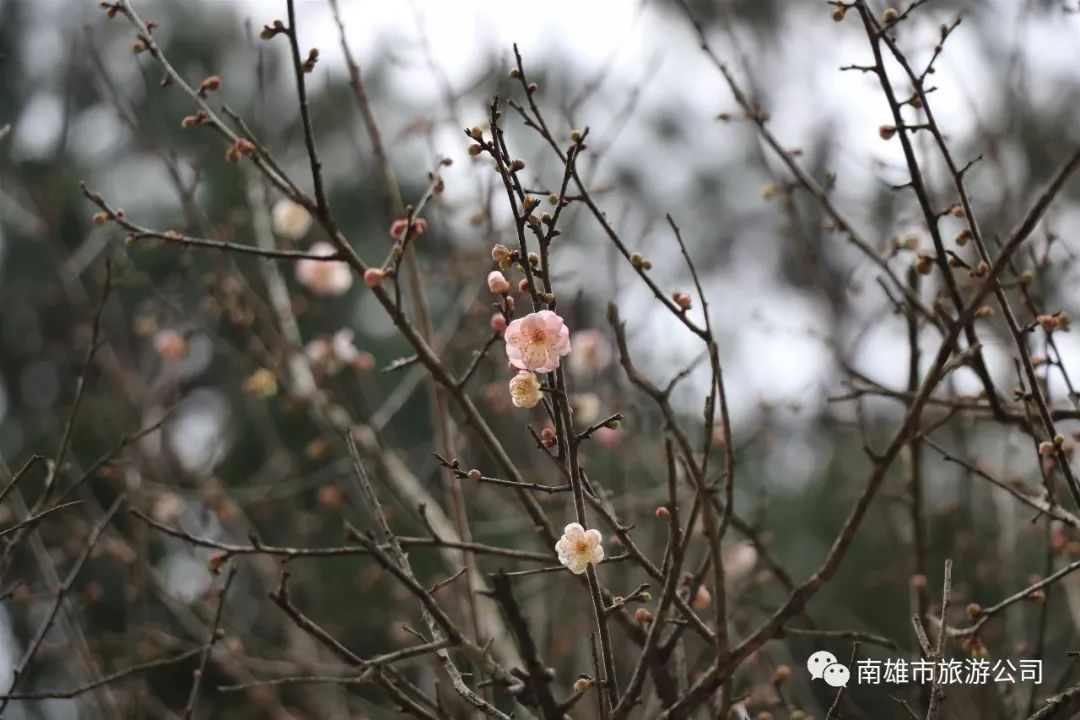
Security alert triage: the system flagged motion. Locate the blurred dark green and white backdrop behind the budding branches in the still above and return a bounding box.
[0,0,1080,718]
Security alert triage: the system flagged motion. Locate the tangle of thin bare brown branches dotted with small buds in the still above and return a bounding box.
[6,0,1080,720]
